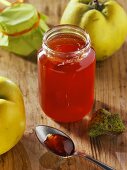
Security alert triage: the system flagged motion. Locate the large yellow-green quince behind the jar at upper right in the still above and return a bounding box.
[60,0,127,61]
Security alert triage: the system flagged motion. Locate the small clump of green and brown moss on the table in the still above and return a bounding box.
[89,109,125,137]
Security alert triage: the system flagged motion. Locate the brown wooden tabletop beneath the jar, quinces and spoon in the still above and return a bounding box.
[0,0,127,170]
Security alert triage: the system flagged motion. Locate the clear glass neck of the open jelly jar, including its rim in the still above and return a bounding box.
[39,25,91,62]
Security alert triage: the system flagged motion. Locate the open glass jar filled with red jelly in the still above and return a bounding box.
[38,25,95,122]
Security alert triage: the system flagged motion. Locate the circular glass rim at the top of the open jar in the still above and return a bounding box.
[42,24,91,55]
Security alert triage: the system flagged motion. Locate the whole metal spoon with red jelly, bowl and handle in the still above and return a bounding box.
[35,125,115,170]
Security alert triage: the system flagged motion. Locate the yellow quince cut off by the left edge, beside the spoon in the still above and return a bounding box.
[0,77,26,155]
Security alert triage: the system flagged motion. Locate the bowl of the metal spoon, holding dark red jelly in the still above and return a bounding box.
[36,125,75,157]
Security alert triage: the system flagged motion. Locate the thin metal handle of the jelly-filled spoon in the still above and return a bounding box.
[74,152,115,170]
